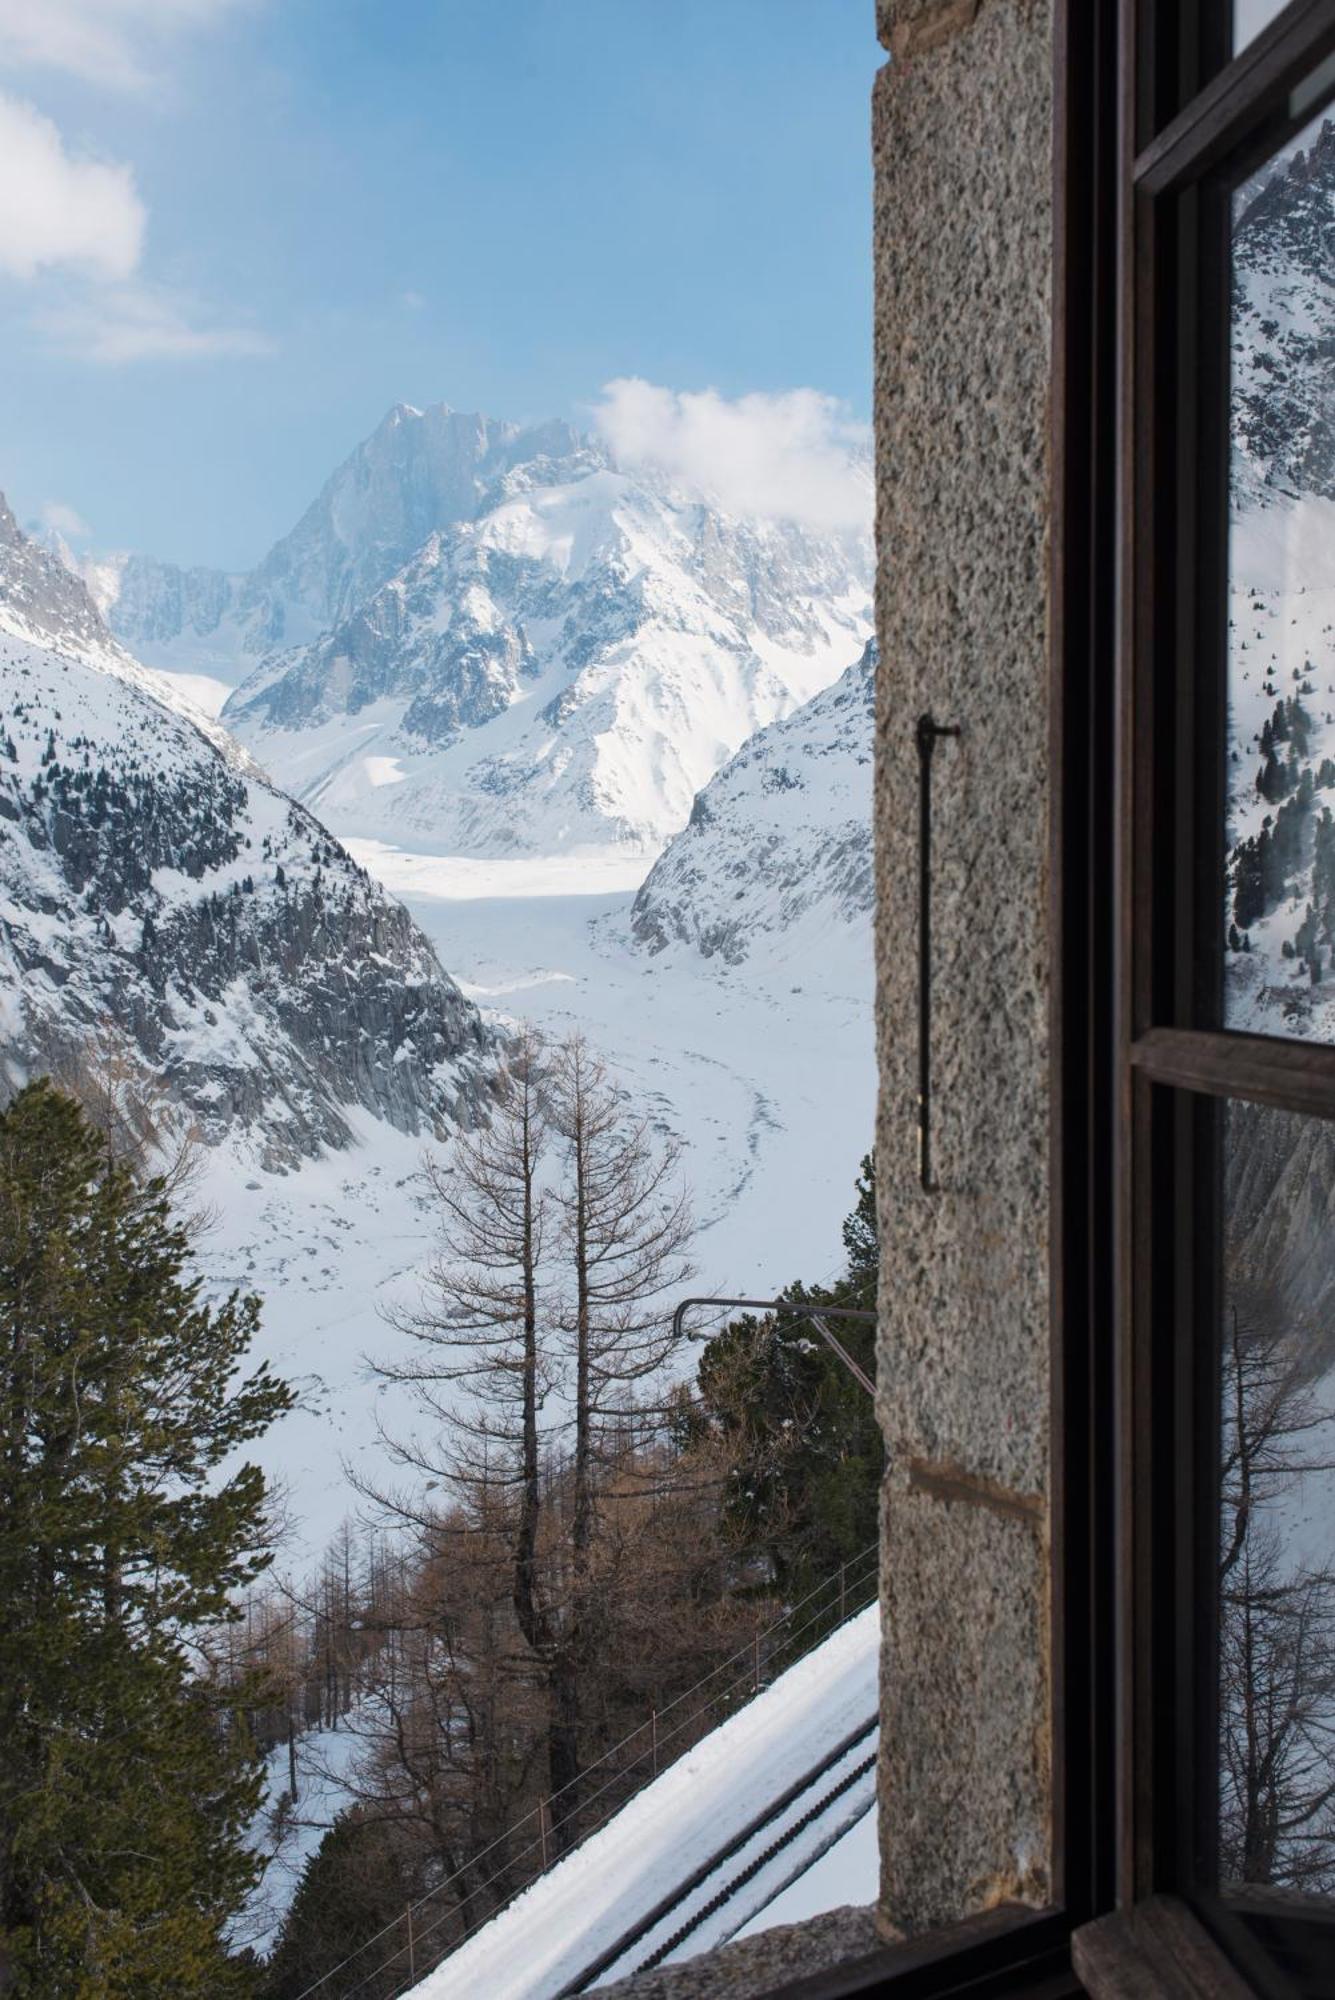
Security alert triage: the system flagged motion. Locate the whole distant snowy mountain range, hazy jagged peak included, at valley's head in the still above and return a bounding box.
[88,404,871,856]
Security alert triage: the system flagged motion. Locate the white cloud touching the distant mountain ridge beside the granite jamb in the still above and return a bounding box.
[594,376,873,530]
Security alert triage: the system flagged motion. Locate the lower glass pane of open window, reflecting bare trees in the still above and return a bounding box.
[1217,1104,1335,1968]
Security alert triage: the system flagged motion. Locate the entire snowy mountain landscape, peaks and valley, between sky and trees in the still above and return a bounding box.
[0,412,875,1984]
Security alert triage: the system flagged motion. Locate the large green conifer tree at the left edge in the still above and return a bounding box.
[0,1082,292,2000]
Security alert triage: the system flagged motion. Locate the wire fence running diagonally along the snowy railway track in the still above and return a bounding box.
[287,1544,879,2000]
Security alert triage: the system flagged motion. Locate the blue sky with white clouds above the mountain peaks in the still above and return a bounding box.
[0,0,881,566]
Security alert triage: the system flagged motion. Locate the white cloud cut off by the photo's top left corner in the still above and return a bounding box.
[0,0,238,90]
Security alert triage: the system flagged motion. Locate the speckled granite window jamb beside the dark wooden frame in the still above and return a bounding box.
[873,0,1051,1932]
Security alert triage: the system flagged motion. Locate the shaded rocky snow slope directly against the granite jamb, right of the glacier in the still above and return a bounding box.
[632,640,877,966]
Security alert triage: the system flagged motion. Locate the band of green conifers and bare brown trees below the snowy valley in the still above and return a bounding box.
[0,1036,881,2000]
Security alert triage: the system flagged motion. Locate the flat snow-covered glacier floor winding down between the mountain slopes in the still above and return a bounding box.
[195,840,875,1566]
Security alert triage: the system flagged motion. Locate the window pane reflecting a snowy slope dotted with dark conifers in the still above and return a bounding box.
[1223,105,1335,1040]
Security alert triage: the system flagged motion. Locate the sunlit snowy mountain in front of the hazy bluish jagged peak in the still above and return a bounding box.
[226,468,867,856]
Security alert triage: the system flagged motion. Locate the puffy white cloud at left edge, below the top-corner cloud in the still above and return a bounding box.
[0,94,146,278]
